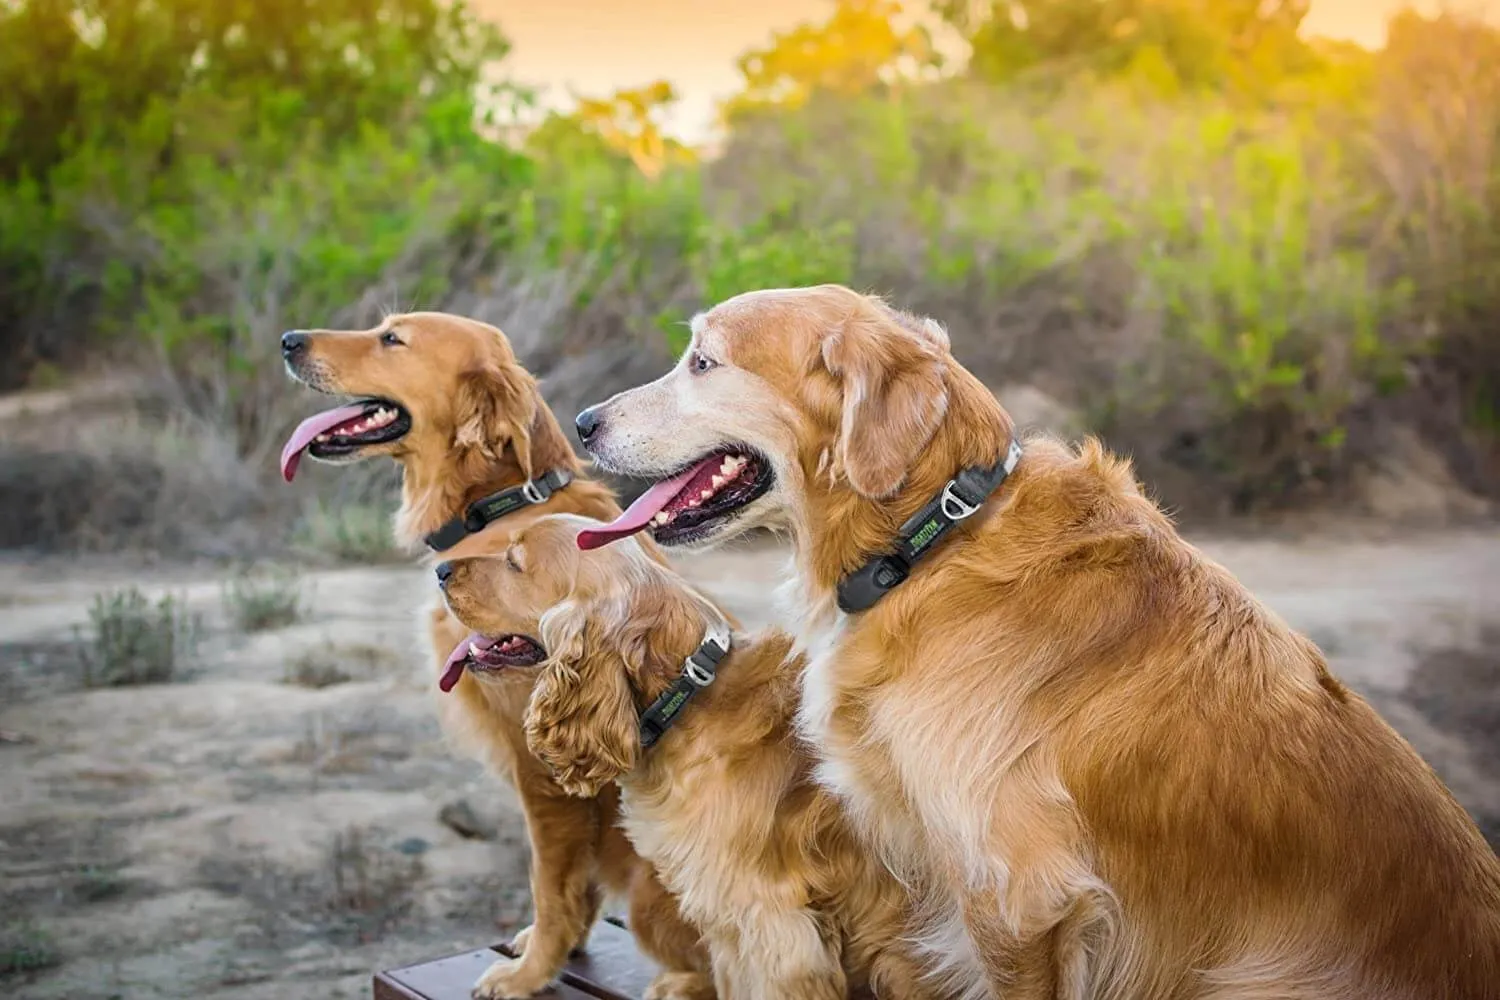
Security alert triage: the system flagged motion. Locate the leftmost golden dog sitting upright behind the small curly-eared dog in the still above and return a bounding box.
[282,313,713,1000]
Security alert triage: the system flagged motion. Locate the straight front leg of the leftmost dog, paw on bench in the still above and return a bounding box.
[474,784,603,1000]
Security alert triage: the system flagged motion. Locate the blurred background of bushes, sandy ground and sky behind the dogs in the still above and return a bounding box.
[0,0,1500,1000]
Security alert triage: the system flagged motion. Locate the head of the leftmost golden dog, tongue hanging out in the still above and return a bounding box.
[282,312,539,481]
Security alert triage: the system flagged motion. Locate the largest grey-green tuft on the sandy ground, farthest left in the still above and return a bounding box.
[80,586,201,688]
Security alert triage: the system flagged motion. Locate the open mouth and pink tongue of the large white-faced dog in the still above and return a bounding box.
[578,445,776,549]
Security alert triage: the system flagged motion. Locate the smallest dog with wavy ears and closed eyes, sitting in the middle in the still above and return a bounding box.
[438,514,936,1000]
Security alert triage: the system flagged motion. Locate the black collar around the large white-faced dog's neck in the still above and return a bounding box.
[839,439,1022,613]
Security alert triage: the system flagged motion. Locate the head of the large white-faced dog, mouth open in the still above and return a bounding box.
[578,285,1010,546]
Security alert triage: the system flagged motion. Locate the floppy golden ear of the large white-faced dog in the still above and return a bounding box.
[824,298,948,499]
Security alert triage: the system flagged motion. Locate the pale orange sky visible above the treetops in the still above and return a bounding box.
[474,0,1464,141]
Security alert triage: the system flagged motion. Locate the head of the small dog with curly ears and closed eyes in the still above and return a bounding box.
[438,514,717,796]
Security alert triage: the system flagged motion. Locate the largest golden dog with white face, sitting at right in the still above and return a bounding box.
[578,286,1500,1000]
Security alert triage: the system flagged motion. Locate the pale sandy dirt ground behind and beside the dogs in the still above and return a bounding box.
[0,531,1500,1000]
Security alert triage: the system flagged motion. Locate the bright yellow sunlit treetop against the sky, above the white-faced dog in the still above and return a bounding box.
[726,0,938,117]
